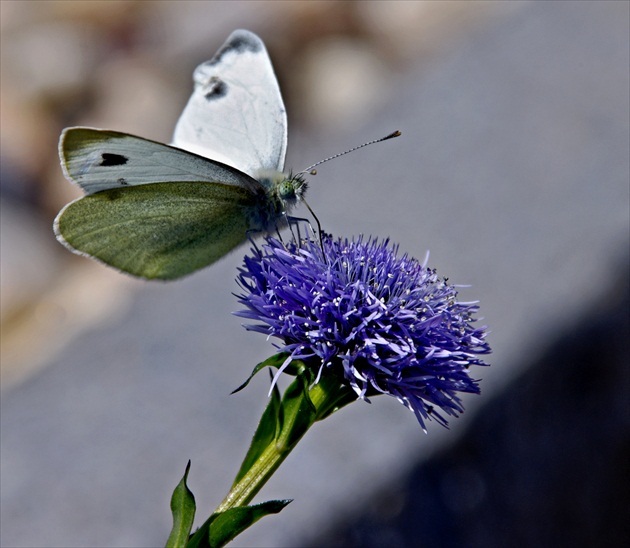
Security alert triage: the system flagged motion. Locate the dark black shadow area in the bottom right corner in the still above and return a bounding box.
[309,258,630,547]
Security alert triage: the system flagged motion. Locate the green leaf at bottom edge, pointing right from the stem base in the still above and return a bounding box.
[187,500,291,548]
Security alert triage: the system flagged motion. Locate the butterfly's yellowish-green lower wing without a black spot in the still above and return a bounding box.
[55,182,260,280]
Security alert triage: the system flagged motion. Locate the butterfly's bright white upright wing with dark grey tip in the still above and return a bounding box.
[173,30,287,177]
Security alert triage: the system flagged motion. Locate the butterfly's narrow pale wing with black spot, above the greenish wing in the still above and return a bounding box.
[59,127,262,194]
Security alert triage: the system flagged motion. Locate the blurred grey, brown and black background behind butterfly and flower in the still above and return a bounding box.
[0,0,630,547]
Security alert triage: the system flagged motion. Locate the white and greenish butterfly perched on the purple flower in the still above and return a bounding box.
[54,30,307,280]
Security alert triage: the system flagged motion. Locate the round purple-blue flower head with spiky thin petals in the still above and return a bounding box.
[236,235,490,429]
